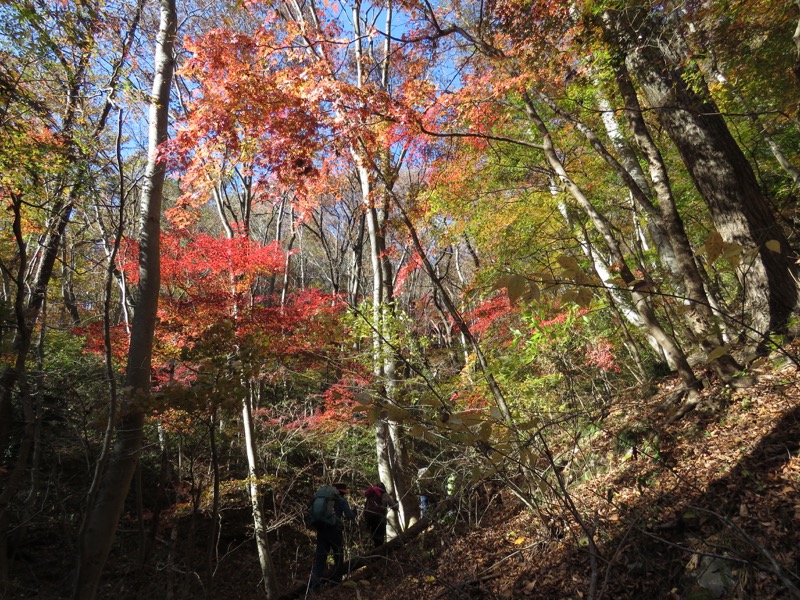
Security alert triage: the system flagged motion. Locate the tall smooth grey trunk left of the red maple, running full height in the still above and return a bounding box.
[73,0,177,600]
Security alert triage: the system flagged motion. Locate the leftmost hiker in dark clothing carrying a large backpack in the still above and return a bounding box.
[309,483,356,592]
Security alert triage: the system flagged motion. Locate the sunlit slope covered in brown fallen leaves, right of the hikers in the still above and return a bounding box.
[315,346,800,600]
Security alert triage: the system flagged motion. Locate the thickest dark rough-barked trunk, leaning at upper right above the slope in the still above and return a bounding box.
[602,10,798,342]
